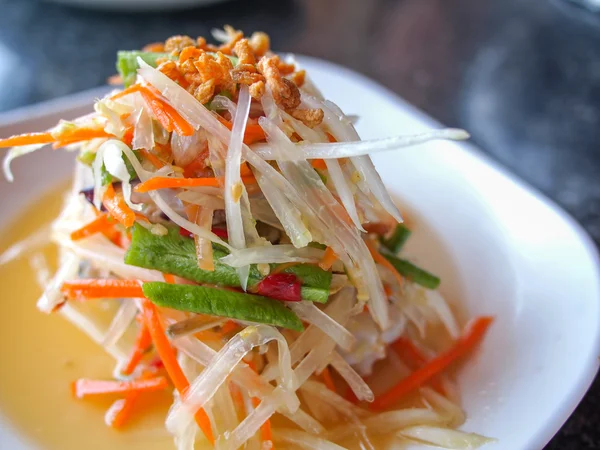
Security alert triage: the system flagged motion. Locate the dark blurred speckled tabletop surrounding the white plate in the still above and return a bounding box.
[0,0,600,450]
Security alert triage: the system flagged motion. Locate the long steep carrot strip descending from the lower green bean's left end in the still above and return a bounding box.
[142,299,215,444]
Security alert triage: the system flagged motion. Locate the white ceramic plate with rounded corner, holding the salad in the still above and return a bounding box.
[0,58,600,450]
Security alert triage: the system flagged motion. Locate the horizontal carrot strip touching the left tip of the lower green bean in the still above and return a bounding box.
[60,279,144,299]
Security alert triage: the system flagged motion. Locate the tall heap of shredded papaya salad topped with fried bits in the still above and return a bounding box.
[0,26,493,450]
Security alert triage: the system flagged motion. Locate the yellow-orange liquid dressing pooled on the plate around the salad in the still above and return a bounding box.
[0,188,465,450]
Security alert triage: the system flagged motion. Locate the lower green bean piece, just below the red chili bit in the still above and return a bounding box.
[143,282,304,331]
